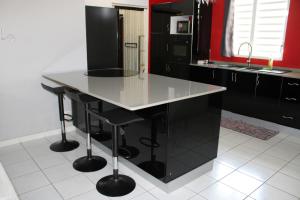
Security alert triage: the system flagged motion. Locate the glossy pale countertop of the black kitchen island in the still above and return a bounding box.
[43,71,226,111]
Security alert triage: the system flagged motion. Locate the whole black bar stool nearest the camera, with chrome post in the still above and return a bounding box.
[88,108,144,197]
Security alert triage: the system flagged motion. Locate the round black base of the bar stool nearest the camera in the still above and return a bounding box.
[97,175,136,197]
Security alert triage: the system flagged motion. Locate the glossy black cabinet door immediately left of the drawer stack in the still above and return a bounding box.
[255,74,282,122]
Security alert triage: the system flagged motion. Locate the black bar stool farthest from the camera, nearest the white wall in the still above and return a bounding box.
[41,83,79,152]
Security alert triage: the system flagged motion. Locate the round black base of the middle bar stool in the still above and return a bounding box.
[73,156,107,172]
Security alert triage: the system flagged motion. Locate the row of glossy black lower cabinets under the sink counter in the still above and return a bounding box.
[152,63,300,129]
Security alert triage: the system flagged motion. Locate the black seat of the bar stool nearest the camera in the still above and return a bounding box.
[89,108,144,126]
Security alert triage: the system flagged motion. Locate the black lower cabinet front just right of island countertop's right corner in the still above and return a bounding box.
[223,70,257,115]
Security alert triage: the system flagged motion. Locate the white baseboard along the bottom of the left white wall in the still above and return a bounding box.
[0,126,76,147]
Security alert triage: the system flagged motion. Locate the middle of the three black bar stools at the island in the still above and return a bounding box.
[65,89,107,172]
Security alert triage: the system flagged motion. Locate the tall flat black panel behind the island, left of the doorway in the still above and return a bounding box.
[85,6,122,71]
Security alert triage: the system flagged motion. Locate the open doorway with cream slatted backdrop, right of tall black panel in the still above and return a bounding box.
[116,6,146,72]
